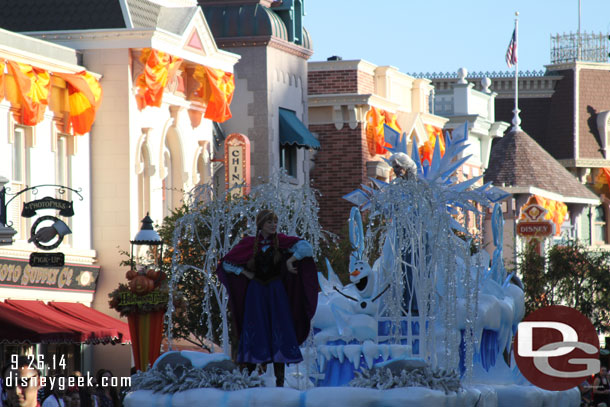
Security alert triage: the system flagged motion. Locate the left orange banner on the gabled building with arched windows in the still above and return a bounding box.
[136,48,182,110]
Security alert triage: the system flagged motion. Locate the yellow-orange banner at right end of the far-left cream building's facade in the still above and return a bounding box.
[55,71,102,134]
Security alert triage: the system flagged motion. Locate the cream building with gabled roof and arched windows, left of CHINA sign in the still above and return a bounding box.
[2,0,239,376]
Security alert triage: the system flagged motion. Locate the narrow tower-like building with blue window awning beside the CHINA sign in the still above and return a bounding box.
[199,0,320,186]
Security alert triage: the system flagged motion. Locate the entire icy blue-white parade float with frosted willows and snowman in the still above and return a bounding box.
[125,125,580,407]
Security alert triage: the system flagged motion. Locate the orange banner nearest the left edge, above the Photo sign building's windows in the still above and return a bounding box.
[7,61,51,126]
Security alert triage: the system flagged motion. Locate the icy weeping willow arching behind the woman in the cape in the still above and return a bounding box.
[158,176,328,354]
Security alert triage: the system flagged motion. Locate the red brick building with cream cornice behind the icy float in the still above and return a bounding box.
[308,60,447,233]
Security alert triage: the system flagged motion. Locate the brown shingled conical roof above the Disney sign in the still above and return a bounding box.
[485,131,599,202]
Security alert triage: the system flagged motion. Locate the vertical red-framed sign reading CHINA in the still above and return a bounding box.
[224,133,250,197]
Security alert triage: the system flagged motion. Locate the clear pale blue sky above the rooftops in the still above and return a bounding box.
[304,0,610,73]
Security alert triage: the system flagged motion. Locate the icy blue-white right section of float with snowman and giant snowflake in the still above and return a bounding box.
[313,124,523,385]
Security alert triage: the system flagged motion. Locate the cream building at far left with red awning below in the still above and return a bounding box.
[0,30,129,373]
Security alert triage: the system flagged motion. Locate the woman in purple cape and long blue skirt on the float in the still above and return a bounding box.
[216,210,318,387]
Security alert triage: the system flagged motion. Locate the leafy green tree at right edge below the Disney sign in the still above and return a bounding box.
[519,241,610,332]
